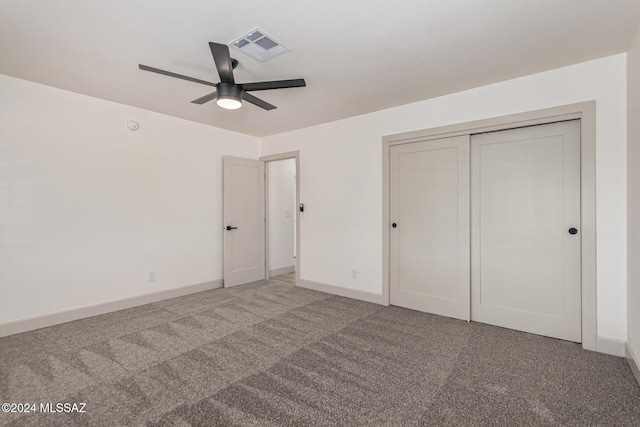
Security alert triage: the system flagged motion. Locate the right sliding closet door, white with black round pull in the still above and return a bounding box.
[471,121,581,342]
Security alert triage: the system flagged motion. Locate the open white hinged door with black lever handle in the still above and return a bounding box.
[223,157,266,287]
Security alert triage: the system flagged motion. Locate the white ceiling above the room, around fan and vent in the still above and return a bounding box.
[0,0,640,136]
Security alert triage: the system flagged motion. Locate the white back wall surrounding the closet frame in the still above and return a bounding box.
[261,54,627,340]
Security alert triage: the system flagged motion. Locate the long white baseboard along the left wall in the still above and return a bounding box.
[0,279,222,337]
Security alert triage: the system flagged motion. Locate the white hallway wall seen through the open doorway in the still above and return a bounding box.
[269,159,296,270]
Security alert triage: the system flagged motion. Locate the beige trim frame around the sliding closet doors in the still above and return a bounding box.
[382,101,597,351]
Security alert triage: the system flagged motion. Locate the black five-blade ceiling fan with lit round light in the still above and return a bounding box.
[138,42,307,110]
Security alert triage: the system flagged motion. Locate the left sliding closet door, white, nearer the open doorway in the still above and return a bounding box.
[389,135,470,320]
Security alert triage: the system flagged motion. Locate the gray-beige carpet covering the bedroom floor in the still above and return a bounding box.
[0,280,640,426]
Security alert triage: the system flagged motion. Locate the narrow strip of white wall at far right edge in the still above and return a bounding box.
[627,26,640,361]
